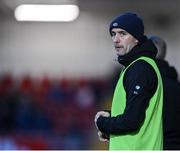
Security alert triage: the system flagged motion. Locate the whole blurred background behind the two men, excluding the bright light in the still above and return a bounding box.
[0,0,180,150]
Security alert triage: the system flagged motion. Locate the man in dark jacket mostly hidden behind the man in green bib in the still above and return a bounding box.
[149,36,180,150]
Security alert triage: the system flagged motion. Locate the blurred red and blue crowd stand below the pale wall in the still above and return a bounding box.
[0,74,116,149]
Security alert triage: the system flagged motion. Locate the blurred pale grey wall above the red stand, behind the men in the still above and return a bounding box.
[0,0,180,77]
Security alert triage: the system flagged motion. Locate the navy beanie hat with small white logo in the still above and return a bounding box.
[109,12,144,41]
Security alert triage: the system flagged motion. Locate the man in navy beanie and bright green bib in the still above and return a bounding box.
[94,12,163,150]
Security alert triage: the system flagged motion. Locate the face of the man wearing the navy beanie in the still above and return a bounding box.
[111,28,138,56]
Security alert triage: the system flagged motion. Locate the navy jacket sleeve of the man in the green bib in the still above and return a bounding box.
[97,61,158,135]
